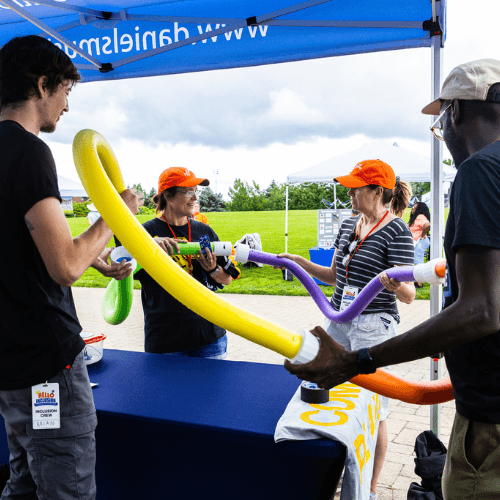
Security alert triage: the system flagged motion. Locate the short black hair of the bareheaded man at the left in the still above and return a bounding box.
[0,35,81,110]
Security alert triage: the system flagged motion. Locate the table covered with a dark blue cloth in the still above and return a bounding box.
[0,350,345,500]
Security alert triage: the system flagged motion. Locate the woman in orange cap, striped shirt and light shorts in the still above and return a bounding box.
[281,160,415,500]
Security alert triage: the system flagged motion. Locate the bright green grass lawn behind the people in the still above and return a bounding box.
[68,209,448,299]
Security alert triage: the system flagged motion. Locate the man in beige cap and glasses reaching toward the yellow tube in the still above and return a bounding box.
[285,59,500,500]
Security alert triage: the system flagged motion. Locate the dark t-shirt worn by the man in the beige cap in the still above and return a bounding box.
[444,142,500,424]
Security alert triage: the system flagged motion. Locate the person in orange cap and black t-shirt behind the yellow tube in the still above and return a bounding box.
[127,167,240,359]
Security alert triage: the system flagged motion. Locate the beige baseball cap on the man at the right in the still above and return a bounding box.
[422,59,500,115]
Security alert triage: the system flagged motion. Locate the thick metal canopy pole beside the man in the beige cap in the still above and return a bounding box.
[430,5,444,437]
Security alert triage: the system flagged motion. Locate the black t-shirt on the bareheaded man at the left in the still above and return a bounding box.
[0,121,85,390]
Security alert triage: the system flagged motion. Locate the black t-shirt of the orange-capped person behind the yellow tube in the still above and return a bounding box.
[135,218,239,353]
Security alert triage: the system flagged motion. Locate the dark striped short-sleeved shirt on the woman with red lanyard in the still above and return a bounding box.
[332,215,414,323]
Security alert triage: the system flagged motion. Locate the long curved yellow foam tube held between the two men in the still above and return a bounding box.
[73,129,302,359]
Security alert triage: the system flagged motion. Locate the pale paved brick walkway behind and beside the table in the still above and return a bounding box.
[73,288,455,500]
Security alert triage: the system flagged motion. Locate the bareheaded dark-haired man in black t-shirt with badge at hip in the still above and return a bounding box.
[0,36,141,500]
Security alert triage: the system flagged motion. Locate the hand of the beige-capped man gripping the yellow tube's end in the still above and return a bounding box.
[285,326,358,389]
